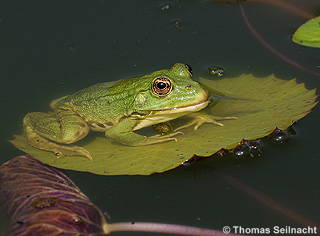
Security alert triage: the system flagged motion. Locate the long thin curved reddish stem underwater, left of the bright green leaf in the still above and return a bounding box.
[239,3,320,77]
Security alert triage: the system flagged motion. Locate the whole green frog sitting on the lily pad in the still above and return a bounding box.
[23,63,229,159]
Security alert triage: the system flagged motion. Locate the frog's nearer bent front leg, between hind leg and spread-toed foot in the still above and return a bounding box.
[105,118,182,146]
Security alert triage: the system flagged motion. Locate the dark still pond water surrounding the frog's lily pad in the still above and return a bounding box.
[0,0,320,235]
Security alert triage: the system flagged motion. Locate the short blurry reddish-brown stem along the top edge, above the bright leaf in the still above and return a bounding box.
[247,0,315,19]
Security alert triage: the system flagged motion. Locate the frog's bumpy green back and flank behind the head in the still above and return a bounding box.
[54,78,144,123]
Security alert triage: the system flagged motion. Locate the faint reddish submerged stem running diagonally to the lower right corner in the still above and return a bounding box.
[218,173,320,229]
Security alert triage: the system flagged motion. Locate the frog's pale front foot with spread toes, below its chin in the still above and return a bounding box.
[174,112,238,131]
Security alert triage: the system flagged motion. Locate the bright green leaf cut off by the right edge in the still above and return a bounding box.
[292,16,320,48]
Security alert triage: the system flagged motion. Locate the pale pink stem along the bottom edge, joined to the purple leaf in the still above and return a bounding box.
[108,222,241,236]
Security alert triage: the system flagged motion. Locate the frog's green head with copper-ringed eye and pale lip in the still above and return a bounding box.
[134,63,208,116]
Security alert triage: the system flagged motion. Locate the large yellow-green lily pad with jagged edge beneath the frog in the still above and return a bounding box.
[11,74,317,175]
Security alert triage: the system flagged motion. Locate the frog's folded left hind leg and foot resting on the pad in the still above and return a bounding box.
[23,110,92,159]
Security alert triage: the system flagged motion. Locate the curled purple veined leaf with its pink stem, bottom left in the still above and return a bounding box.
[0,155,238,236]
